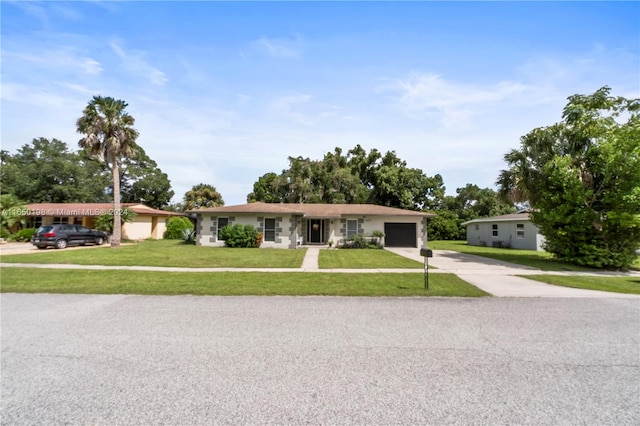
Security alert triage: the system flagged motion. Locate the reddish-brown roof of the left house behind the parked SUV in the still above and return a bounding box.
[26,203,182,217]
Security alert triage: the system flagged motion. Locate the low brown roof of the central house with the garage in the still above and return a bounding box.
[187,202,435,218]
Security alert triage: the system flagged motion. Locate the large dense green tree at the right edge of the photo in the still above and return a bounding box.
[498,87,640,269]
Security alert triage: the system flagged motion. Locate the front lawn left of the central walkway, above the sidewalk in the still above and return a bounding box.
[0,240,306,268]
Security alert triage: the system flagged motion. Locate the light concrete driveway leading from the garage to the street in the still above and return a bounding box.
[387,248,640,300]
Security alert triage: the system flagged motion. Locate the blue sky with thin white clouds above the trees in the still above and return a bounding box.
[0,0,640,205]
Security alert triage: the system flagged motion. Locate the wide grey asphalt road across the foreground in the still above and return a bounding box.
[1,293,640,425]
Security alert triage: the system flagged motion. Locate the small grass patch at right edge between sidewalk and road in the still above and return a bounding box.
[523,275,640,294]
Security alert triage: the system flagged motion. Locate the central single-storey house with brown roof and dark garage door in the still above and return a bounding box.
[187,202,435,248]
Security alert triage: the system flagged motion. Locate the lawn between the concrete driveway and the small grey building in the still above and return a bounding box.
[429,241,593,272]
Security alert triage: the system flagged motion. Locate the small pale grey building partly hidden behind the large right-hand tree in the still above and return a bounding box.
[462,211,544,251]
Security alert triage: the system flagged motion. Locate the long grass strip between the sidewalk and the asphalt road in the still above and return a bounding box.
[0,268,488,297]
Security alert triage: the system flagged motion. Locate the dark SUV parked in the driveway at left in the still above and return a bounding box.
[31,225,107,249]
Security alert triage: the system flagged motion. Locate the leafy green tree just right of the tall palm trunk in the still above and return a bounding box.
[121,146,174,209]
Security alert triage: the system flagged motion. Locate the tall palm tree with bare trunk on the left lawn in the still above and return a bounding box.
[76,96,138,248]
